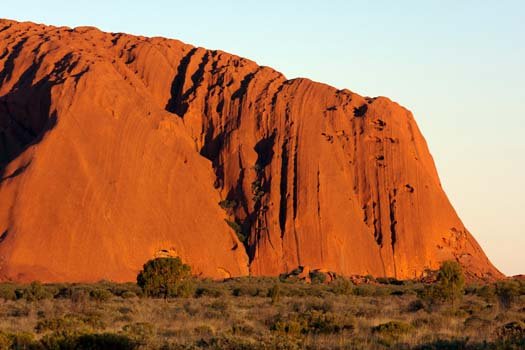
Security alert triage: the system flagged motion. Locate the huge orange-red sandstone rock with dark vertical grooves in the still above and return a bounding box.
[0,20,501,281]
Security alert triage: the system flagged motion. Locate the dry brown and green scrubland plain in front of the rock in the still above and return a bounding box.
[0,262,525,349]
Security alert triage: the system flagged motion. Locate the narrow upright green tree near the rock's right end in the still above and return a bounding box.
[433,260,465,304]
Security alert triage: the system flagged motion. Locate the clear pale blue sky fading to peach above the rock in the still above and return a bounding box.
[0,0,525,275]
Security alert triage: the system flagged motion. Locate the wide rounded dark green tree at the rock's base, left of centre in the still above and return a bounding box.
[137,257,193,298]
